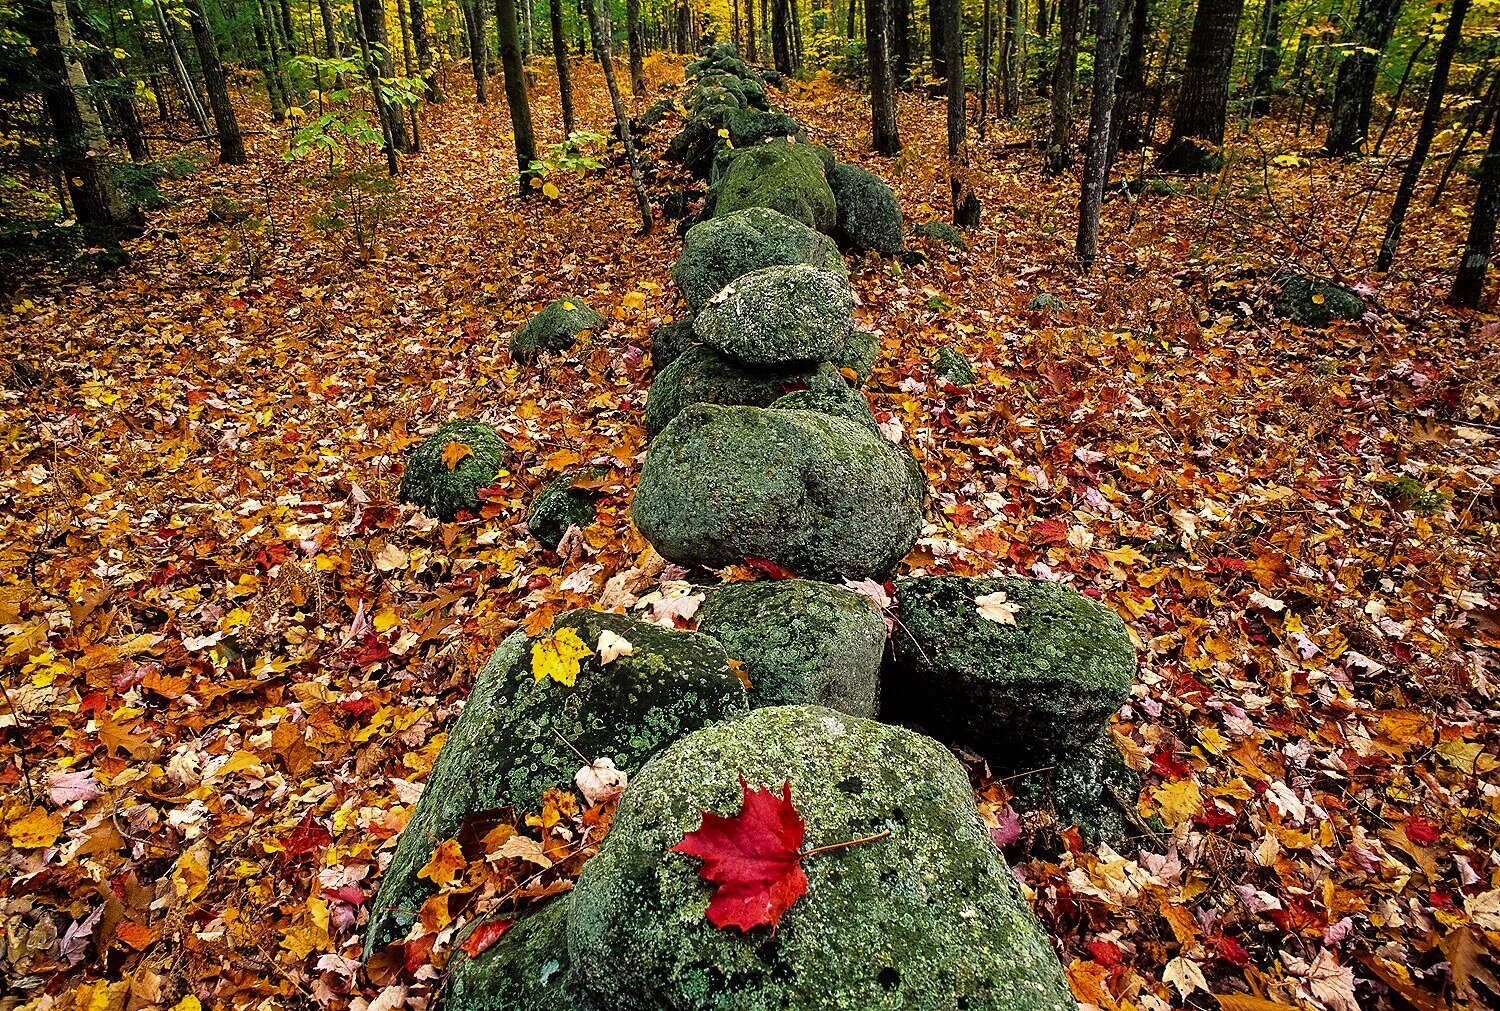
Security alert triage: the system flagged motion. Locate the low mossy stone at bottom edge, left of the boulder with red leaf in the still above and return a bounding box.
[443,896,588,1011]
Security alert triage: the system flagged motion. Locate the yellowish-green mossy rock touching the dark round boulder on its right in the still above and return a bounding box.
[711,141,837,233]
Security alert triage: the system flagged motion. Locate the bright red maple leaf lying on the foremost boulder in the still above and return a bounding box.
[672,776,807,930]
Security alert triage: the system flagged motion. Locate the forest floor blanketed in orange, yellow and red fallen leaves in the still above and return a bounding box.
[0,53,1500,1011]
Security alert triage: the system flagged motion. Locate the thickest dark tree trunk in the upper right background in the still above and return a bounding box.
[1157,0,1245,173]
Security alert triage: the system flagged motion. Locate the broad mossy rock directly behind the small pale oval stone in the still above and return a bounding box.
[672,207,849,312]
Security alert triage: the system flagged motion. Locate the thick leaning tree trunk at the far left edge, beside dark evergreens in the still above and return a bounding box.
[17,0,143,246]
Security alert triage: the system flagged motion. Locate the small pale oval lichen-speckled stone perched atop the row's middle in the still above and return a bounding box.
[693,264,854,365]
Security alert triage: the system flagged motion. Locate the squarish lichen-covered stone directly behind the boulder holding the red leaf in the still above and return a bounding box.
[698,579,885,717]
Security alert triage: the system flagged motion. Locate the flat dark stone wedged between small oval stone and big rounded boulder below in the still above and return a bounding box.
[644,345,849,435]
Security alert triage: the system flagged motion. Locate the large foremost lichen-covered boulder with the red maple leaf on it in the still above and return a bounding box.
[569,707,1076,1011]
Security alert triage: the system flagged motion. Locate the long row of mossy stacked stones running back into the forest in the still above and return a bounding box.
[384,45,1136,1011]
